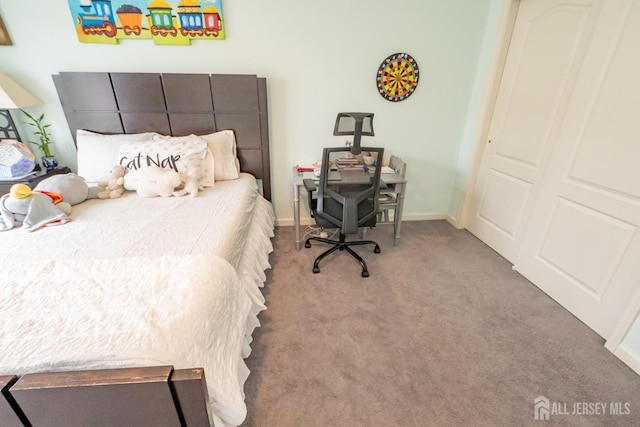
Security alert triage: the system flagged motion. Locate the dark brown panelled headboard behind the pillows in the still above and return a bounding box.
[53,72,271,200]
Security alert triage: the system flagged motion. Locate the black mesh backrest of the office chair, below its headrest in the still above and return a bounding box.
[315,147,384,234]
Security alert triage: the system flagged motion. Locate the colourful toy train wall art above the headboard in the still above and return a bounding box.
[68,0,225,45]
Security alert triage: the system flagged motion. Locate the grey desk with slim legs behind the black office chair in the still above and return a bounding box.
[292,167,407,249]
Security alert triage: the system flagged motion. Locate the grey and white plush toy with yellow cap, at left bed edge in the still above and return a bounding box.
[0,184,71,231]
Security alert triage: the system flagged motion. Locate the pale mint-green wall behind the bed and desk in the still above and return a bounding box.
[0,0,492,224]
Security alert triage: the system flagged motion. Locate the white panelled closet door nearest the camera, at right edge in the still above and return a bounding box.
[515,0,640,339]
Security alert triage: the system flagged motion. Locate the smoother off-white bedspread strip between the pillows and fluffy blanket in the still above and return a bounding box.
[0,174,258,267]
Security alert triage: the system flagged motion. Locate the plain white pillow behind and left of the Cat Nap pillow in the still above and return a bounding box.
[76,129,156,183]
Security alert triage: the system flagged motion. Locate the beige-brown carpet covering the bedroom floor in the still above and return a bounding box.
[243,221,640,427]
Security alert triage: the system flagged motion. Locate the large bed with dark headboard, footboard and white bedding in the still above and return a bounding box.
[0,73,274,426]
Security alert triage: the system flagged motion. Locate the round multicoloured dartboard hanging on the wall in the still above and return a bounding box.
[377,53,420,102]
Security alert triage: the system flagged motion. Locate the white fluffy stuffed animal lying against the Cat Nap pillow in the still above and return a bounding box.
[124,166,182,197]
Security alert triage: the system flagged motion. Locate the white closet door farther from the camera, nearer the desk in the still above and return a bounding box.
[467,0,602,262]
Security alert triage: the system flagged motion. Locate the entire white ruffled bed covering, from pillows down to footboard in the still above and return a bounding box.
[0,175,273,425]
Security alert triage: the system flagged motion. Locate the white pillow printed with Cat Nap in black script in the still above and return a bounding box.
[118,134,215,187]
